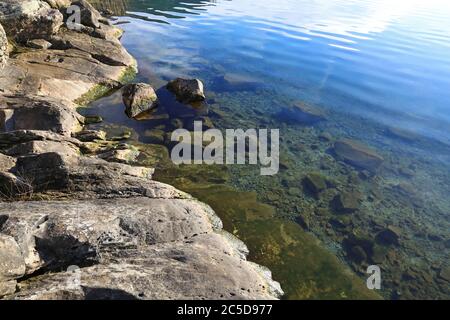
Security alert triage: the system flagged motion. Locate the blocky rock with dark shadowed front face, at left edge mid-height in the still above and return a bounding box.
[0,96,83,135]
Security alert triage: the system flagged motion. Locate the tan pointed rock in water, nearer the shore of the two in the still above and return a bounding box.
[122,83,158,118]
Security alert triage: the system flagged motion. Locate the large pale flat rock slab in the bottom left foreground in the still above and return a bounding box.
[0,197,282,299]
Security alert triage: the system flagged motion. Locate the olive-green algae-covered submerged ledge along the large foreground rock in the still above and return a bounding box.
[154,165,380,299]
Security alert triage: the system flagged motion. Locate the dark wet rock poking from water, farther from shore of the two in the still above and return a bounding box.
[166,78,206,104]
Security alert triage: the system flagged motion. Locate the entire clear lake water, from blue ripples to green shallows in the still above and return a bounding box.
[83,0,450,299]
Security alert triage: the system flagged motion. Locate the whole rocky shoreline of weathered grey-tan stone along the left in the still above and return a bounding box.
[0,0,282,299]
